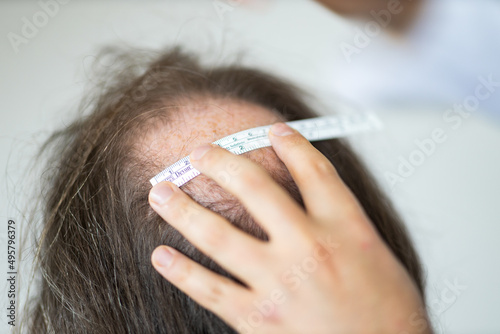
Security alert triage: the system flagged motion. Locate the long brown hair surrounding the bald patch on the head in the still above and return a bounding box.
[25,48,424,334]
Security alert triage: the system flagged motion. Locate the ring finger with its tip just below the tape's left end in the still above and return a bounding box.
[149,182,266,282]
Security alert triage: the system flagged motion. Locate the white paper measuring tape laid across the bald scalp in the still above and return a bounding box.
[149,112,382,187]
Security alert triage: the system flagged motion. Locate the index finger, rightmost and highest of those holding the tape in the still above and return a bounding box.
[269,123,360,220]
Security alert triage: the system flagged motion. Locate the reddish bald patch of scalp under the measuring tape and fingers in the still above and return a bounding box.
[141,98,302,239]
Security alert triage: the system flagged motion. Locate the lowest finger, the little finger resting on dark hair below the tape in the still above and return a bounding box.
[151,246,251,324]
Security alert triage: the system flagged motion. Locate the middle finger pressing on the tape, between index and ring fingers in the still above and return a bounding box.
[189,145,306,239]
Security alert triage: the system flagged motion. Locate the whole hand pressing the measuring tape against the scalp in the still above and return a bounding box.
[149,123,430,334]
